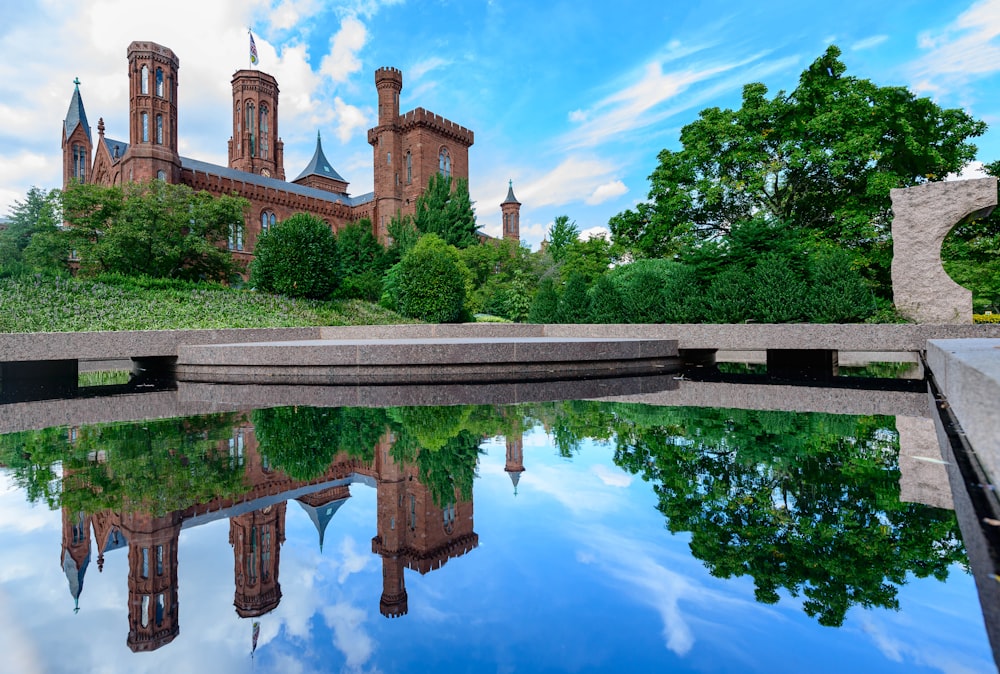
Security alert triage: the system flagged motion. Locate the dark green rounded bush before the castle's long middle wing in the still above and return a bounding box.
[250,213,340,299]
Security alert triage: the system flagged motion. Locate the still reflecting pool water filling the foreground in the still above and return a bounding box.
[0,401,996,674]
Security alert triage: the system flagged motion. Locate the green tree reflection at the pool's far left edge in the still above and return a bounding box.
[0,414,244,515]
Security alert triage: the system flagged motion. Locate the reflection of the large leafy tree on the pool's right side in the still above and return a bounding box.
[596,406,965,626]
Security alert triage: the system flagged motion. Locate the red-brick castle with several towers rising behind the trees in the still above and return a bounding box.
[61,41,520,262]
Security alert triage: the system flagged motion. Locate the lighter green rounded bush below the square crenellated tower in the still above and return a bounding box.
[385,234,468,323]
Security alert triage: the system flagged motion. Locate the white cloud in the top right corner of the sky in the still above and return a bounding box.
[913,0,1000,91]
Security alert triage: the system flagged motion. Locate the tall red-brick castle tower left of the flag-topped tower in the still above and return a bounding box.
[122,42,181,183]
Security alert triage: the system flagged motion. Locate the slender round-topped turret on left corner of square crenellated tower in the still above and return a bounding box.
[368,68,403,241]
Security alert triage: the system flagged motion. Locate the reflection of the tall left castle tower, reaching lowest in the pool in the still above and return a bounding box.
[121,512,181,653]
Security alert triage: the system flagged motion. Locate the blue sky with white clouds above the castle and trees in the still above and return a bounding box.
[0,0,1000,247]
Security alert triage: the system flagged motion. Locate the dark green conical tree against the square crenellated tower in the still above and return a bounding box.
[413,173,479,248]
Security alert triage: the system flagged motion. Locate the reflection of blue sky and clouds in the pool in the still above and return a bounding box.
[0,431,993,674]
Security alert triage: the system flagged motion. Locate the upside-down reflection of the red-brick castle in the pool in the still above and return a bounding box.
[61,424,524,652]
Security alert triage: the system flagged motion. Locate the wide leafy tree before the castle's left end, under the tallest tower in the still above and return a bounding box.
[62,180,248,280]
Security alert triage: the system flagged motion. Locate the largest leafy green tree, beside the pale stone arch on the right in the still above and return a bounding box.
[610,46,986,292]
